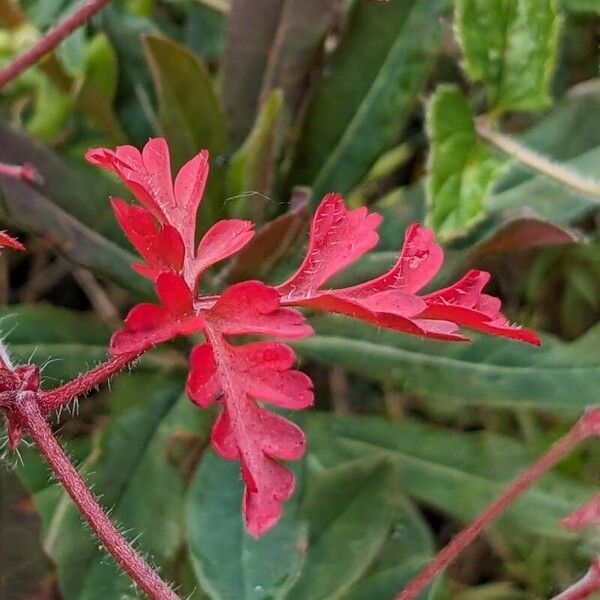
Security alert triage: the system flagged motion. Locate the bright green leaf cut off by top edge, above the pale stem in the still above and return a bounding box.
[455,0,560,112]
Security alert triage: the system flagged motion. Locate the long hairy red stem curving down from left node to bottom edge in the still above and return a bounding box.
[13,392,178,600]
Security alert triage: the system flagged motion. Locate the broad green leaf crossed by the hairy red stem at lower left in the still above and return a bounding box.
[45,376,208,600]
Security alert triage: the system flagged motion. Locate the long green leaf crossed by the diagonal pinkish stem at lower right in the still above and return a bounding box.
[307,412,591,539]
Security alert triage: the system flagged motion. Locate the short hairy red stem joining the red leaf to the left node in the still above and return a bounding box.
[38,352,141,414]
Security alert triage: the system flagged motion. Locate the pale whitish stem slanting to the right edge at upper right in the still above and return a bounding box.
[475,119,600,199]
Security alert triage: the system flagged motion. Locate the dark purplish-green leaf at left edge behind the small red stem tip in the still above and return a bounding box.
[0,125,152,295]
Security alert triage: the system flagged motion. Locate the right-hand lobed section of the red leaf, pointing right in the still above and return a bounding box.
[277,194,539,345]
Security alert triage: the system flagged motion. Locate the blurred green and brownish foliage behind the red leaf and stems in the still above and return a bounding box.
[0,0,600,600]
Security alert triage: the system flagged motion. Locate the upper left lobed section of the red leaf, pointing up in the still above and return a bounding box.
[86,138,254,289]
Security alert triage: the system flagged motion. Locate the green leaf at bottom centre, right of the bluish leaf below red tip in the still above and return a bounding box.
[288,459,392,600]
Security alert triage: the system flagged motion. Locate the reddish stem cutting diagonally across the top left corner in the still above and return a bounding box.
[0,0,110,88]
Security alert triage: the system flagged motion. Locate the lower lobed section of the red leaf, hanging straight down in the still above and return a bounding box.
[187,332,313,537]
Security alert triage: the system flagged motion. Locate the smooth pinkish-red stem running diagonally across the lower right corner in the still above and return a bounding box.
[396,409,600,600]
